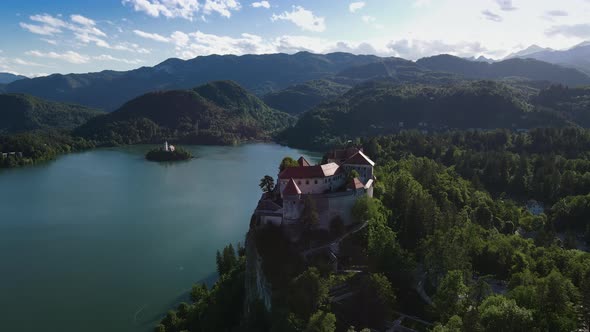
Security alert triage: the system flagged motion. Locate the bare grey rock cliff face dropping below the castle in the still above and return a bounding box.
[245,230,272,312]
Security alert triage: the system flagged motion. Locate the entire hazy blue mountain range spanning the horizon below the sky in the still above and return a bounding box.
[0,52,590,111]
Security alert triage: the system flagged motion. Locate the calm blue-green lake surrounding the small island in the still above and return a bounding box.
[0,144,320,332]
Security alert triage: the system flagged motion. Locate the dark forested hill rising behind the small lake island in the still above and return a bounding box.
[75,81,294,145]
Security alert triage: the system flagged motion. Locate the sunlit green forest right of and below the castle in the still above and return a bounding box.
[157,128,590,332]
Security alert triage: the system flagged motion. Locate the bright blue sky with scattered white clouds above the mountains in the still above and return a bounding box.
[0,0,590,77]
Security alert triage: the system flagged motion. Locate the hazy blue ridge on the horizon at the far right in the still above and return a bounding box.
[416,55,590,86]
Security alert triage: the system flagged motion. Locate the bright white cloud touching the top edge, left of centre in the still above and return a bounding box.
[123,0,241,21]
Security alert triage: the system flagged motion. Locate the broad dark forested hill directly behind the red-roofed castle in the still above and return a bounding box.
[280,81,568,148]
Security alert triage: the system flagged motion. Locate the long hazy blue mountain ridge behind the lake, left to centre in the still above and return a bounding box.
[5,52,379,111]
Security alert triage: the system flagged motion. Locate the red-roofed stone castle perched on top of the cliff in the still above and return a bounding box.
[254,148,375,229]
